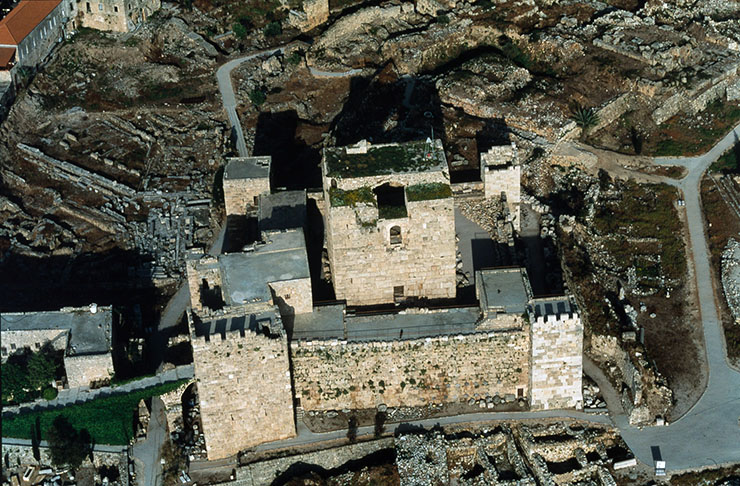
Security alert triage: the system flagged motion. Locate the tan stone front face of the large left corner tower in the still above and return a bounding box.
[192,331,295,460]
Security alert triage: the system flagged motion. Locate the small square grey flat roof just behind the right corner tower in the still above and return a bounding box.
[476,268,529,314]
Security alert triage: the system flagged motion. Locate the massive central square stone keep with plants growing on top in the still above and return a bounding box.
[322,140,456,305]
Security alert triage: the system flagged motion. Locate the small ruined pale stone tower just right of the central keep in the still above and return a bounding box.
[480,142,522,231]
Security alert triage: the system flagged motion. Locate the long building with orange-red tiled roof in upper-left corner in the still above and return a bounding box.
[0,0,69,82]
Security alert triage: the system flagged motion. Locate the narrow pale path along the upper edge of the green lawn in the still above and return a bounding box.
[3,364,194,418]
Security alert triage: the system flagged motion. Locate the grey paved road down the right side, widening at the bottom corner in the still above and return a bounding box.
[613,125,740,471]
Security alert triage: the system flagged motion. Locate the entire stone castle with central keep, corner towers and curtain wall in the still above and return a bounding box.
[181,140,582,459]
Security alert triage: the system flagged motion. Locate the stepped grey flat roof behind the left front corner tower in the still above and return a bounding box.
[218,228,311,305]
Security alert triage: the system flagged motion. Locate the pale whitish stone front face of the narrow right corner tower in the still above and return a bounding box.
[531,313,583,410]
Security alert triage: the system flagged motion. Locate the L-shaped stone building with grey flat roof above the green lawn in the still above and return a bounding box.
[0,304,114,388]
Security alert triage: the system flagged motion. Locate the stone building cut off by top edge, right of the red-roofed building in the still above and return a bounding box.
[69,0,162,32]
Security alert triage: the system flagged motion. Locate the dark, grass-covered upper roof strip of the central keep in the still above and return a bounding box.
[324,140,447,178]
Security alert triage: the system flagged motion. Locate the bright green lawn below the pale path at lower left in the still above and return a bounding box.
[3,380,187,445]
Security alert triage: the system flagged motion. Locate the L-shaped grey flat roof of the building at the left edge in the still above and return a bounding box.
[0,306,113,356]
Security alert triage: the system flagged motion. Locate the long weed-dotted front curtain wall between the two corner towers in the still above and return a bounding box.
[291,327,529,410]
